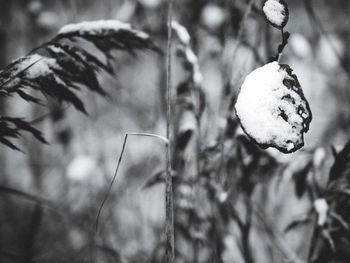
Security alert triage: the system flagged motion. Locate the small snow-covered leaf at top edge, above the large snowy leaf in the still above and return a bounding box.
[263,0,288,27]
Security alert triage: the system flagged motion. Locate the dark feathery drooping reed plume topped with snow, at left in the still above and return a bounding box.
[0,20,160,150]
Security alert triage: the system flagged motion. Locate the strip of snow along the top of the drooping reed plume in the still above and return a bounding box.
[58,20,149,39]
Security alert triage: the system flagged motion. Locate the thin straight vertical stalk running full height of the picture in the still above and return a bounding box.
[165,0,175,263]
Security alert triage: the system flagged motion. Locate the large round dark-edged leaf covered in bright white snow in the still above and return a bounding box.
[235,62,312,153]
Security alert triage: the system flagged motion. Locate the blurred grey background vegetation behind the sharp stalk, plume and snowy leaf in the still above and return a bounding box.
[0,0,350,263]
